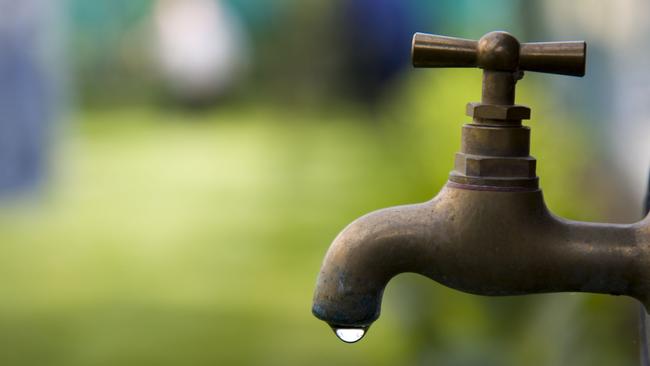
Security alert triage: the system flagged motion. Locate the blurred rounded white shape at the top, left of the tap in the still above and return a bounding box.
[154,0,247,99]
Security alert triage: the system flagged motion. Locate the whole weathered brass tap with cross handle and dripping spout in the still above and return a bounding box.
[312,32,650,340]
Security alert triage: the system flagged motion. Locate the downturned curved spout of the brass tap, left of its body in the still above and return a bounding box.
[312,194,438,328]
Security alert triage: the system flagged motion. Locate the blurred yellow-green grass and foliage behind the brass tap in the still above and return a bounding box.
[0,72,635,365]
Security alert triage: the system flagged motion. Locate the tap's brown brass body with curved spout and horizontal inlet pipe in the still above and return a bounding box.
[312,182,650,328]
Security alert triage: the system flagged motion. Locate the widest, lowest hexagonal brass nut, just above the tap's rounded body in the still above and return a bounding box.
[454,153,537,178]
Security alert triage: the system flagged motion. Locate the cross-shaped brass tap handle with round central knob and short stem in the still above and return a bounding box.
[411,31,587,105]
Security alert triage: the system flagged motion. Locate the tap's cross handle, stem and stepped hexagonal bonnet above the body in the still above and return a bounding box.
[412,32,586,190]
